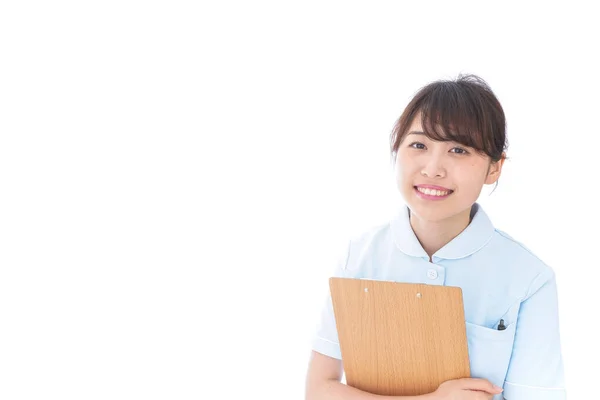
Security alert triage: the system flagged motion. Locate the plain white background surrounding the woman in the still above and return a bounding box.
[0,1,600,400]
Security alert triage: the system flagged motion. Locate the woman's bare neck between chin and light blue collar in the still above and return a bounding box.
[410,208,471,261]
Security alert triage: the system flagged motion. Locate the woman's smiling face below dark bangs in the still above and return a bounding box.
[396,115,503,222]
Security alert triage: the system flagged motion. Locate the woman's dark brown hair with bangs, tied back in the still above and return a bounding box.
[390,74,508,162]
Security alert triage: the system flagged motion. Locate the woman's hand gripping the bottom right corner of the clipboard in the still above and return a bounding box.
[432,378,502,400]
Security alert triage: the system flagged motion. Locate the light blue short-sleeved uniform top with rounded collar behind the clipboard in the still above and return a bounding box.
[313,203,566,400]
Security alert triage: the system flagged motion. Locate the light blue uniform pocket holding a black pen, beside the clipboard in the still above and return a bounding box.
[466,322,517,399]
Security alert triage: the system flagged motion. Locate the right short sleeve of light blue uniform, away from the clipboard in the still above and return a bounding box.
[503,269,566,400]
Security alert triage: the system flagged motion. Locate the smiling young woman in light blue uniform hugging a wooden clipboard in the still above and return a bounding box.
[306,75,565,400]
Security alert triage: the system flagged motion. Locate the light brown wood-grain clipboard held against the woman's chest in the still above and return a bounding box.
[329,277,470,396]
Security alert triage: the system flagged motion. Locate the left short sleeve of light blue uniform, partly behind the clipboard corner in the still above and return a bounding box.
[312,243,350,360]
